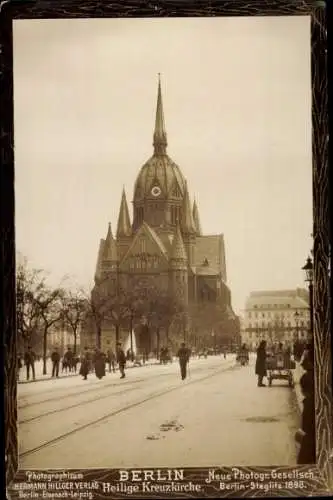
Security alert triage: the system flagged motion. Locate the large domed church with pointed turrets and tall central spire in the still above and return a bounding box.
[85,78,239,349]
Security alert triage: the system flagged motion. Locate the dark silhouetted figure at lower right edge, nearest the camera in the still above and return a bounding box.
[295,371,316,465]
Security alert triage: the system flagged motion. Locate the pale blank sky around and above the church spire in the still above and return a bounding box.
[14,16,312,313]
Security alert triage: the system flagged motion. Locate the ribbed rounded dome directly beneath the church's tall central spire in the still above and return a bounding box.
[134,154,186,200]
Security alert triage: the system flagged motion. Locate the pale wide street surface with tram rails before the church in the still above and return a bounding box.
[18,355,300,469]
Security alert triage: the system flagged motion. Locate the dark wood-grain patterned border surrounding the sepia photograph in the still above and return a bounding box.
[0,0,333,498]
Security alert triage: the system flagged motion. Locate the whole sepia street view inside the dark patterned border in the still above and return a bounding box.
[13,15,316,476]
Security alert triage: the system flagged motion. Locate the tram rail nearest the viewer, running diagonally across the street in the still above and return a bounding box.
[19,364,238,458]
